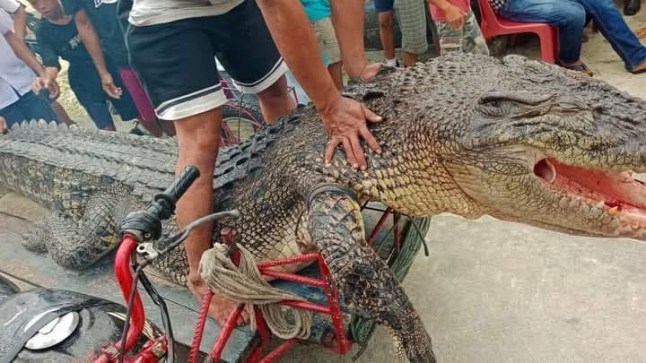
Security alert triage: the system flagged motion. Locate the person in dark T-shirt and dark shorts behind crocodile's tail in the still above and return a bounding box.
[29,0,139,131]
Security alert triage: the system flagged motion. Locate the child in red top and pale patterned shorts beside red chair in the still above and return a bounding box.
[430,0,489,55]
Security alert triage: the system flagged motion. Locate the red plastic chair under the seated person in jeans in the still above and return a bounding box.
[478,0,558,63]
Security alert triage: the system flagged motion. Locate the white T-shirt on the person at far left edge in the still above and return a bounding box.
[0,0,36,109]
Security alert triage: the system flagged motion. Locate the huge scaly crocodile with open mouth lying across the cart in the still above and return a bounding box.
[0,54,646,361]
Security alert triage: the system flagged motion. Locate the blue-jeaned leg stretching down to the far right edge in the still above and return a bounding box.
[571,0,646,71]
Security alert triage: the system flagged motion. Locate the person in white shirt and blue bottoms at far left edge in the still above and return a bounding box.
[0,0,60,127]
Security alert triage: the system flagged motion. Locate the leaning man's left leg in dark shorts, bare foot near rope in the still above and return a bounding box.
[125,15,243,324]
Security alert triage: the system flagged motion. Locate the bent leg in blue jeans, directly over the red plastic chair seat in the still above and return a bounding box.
[499,0,585,65]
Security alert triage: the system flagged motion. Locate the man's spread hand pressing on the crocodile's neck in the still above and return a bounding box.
[320,95,382,170]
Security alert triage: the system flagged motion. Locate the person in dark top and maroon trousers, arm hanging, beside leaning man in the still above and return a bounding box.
[60,0,175,137]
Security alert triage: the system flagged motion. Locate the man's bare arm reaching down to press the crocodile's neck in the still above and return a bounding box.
[258,0,381,169]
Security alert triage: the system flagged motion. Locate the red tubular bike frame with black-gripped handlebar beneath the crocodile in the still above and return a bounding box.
[88,168,428,363]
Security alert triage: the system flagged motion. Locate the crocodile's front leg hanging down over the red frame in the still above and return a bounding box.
[309,190,435,362]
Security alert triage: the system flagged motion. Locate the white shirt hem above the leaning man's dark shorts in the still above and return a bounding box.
[129,0,246,26]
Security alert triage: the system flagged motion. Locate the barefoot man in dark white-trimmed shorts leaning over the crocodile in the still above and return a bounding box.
[119,0,381,324]
